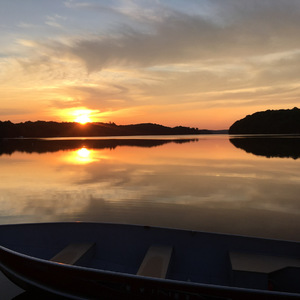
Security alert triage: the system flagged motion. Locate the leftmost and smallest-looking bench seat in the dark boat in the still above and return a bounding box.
[50,243,95,265]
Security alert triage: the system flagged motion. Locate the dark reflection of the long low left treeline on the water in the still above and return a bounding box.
[0,139,197,156]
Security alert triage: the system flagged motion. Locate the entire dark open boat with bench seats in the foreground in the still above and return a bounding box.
[0,222,300,300]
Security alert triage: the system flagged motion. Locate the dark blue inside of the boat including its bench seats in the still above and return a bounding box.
[0,223,300,293]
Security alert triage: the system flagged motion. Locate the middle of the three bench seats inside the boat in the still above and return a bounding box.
[137,246,173,278]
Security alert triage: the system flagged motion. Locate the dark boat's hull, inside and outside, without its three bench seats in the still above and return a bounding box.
[0,223,300,299]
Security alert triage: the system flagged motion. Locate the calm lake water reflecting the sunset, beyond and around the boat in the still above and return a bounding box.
[0,135,300,300]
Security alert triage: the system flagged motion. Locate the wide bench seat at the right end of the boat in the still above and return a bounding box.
[229,252,300,274]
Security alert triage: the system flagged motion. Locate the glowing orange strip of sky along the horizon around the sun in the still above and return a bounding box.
[0,105,293,130]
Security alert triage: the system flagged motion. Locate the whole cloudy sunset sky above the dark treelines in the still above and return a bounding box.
[0,0,300,129]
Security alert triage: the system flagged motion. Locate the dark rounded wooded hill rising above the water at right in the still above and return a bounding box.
[229,107,300,134]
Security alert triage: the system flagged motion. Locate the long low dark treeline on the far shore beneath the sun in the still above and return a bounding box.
[0,121,217,138]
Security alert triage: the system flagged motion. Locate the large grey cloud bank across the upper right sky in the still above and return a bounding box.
[53,0,300,72]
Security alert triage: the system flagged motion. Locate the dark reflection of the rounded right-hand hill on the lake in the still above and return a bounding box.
[230,136,300,159]
